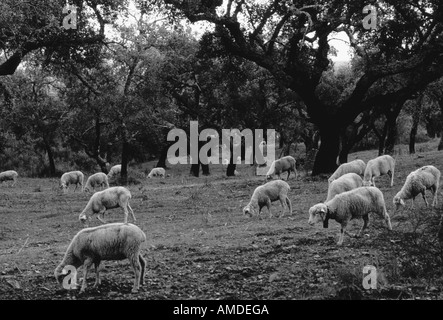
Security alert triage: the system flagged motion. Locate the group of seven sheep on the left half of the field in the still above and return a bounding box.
[0,165,165,292]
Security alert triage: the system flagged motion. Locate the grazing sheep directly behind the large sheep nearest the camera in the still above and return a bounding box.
[79,187,136,223]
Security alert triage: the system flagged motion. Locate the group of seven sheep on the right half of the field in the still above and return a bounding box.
[243,155,441,245]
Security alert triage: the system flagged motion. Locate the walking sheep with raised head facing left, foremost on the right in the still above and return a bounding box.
[308,187,392,245]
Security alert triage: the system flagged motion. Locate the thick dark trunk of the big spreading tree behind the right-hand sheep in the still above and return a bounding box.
[312,125,340,176]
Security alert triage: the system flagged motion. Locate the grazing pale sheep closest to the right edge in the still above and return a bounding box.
[393,166,441,209]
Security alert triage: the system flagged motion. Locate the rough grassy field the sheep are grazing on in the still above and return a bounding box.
[0,141,443,300]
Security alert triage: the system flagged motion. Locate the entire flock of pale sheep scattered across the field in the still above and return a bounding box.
[0,155,440,292]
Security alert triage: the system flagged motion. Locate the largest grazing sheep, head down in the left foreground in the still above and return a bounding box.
[54,223,146,293]
